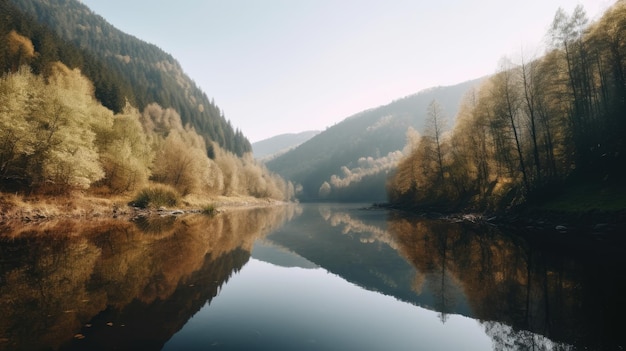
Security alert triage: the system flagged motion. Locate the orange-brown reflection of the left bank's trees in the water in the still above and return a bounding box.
[0,207,294,350]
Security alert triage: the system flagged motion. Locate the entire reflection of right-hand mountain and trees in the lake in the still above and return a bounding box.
[265,205,626,350]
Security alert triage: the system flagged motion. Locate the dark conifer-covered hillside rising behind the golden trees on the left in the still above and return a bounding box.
[7,0,251,156]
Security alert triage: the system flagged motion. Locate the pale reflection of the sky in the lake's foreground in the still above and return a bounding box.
[164,258,492,350]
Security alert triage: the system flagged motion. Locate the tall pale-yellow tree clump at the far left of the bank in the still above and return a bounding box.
[0,64,104,190]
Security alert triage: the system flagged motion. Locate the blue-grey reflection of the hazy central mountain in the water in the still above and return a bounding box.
[258,205,469,315]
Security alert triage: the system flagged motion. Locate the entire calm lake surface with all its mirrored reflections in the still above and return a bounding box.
[0,204,626,350]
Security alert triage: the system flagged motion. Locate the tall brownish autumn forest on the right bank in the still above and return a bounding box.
[388,0,626,211]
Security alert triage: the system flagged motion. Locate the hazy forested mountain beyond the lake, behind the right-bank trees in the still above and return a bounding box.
[267,78,482,201]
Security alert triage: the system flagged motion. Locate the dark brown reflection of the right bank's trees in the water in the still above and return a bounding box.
[388,218,626,350]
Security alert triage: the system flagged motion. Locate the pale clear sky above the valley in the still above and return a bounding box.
[82,0,615,142]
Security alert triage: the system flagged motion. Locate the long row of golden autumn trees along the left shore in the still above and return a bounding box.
[0,31,293,204]
